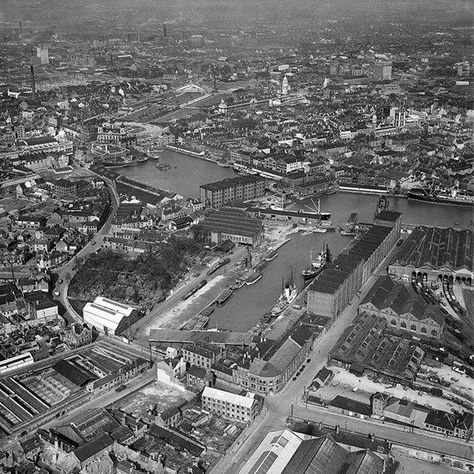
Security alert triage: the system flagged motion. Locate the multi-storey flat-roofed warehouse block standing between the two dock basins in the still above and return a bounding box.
[200,176,266,208]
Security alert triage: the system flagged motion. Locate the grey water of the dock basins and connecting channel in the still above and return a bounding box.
[120,151,474,331]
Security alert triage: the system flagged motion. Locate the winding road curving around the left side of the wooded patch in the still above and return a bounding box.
[54,178,120,323]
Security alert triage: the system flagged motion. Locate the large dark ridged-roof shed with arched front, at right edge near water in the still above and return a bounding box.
[389,227,474,285]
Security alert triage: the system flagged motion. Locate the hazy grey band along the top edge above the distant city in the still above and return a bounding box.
[0,0,474,28]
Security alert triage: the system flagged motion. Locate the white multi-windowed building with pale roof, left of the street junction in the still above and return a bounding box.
[201,387,261,422]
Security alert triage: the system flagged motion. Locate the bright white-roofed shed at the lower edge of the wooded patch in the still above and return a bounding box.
[83,296,137,334]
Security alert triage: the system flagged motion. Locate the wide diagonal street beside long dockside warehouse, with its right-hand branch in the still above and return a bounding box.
[211,250,474,474]
